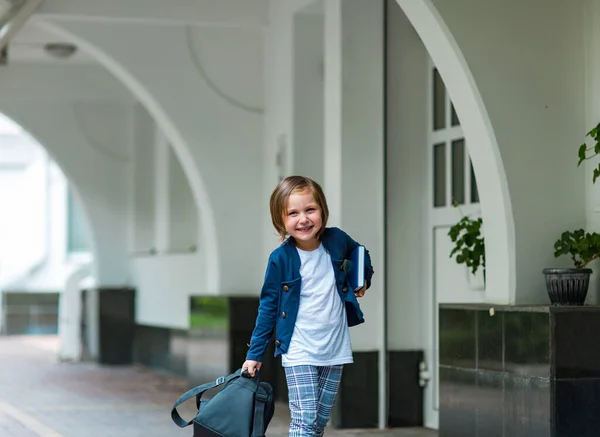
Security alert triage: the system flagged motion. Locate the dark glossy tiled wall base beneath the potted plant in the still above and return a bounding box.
[439,305,600,437]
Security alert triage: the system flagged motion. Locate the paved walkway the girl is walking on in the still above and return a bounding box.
[0,336,437,437]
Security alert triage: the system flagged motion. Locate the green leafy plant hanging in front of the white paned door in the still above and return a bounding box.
[448,201,485,274]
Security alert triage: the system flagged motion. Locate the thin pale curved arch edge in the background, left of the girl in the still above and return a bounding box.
[39,20,220,292]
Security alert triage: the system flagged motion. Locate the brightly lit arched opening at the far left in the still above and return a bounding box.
[0,115,96,359]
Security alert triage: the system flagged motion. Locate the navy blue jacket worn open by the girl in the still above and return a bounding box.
[246,228,373,362]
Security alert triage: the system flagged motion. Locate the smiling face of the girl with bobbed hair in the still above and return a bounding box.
[283,189,322,250]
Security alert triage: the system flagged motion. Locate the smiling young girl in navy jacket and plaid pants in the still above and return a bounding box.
[242,176,373,437]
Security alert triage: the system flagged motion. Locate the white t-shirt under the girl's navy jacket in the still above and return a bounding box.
[281,244,353,367]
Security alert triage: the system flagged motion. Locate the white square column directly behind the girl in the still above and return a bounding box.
[324,0,387,428]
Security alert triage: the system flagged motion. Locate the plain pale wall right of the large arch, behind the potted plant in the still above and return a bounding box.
[434,0,587,304]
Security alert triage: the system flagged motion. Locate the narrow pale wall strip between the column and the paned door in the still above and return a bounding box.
[386,0,429,350]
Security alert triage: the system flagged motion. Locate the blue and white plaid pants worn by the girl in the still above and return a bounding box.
[285,366,343,437]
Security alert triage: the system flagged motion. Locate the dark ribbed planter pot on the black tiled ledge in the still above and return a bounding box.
[543,269,592,305]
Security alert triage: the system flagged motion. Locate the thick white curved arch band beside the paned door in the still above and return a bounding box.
[396,0,516,304]
